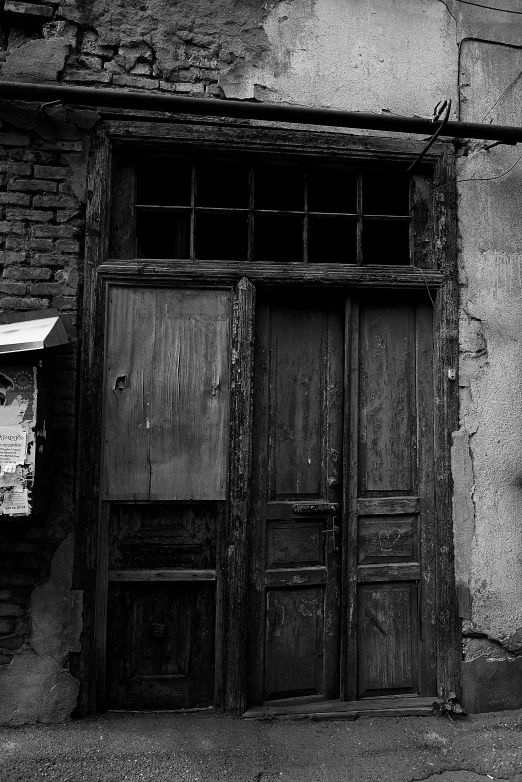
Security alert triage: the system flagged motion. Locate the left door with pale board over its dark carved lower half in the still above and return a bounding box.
[99,285,230,709]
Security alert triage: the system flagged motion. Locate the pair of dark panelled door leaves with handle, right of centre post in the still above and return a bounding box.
[248,291,436,705]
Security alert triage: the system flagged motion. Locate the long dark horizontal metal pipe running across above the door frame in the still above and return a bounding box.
[0,81,522,144]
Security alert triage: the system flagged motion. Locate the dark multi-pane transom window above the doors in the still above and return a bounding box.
[111,156,424,265]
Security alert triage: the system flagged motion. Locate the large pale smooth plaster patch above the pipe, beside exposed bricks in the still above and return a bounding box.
[219,0,458,116]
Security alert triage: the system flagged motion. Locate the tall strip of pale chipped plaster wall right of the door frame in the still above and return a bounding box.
[455,36,522,656]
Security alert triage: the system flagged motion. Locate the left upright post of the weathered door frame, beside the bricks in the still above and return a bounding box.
[72,136,111,716]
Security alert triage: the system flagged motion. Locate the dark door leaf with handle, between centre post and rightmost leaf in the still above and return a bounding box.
[249,296,343,703]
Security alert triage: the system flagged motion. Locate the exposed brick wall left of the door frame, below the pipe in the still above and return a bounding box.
[0,123,85,684]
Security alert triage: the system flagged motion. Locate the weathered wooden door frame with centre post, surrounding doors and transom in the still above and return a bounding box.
[70,121,461,716]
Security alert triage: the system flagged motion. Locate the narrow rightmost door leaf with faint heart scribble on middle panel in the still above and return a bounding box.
[345,301,435,698]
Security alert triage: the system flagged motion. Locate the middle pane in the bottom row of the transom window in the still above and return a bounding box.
[254,214,303,263]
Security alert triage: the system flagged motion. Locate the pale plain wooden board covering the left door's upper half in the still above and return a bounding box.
[104,286,229,501]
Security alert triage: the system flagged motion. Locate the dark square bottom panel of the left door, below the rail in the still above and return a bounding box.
[107,583,215,709]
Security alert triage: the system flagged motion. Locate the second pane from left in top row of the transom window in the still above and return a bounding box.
[196,161,248,209]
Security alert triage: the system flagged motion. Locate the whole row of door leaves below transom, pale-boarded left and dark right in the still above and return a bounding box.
[97,280,436,711]
